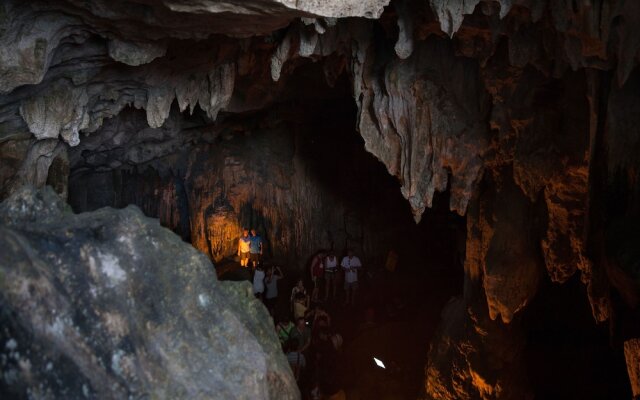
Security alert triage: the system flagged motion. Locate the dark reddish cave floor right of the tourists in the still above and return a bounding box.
[217,249,462,400]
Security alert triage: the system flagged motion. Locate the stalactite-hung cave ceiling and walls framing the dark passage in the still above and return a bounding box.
[0,0,640,399]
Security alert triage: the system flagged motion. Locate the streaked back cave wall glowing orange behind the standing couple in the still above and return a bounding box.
[69,93,417,270]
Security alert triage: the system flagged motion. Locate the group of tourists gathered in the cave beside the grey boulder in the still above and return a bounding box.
[238,229,362,399]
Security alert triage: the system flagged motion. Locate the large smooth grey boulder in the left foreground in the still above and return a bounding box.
[0,187,299,399]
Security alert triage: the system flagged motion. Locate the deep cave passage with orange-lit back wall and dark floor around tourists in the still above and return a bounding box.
[69,61,466,399]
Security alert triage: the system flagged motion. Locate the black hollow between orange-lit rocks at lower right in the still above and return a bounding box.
[523,274,631,400]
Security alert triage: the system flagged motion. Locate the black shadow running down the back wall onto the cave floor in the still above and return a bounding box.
[217,66,466,399]
